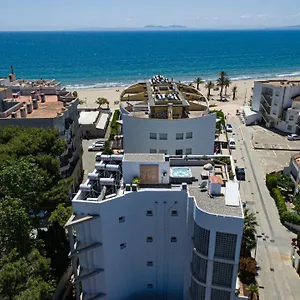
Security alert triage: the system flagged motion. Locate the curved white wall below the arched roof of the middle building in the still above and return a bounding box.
[122,114,216,155]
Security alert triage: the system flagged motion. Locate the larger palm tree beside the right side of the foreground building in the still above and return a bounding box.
[241,208,258,257]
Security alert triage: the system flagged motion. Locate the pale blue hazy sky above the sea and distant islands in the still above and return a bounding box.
[0,0,300,31]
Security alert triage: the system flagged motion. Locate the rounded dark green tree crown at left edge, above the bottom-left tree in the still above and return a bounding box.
[0,198,33,254]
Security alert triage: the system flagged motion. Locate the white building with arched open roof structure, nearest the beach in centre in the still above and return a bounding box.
[120,75,216,155]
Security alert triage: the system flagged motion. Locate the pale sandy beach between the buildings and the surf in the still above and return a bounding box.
[77,77,300,114]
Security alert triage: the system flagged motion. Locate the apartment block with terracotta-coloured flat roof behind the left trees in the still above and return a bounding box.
[0,78,83,192]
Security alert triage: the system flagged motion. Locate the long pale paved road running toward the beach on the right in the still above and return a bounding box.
[227,116,300,300]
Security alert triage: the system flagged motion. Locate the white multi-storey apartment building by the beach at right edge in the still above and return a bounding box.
[252,79,300,133]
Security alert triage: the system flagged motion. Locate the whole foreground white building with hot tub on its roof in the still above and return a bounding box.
[66,154,244,300]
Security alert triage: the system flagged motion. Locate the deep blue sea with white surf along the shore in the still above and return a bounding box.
[0,30,300,88]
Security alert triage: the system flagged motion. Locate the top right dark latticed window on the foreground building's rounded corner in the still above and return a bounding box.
[215,232,237,260]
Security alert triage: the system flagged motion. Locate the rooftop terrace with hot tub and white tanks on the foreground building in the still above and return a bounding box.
[73,154,243,217]
